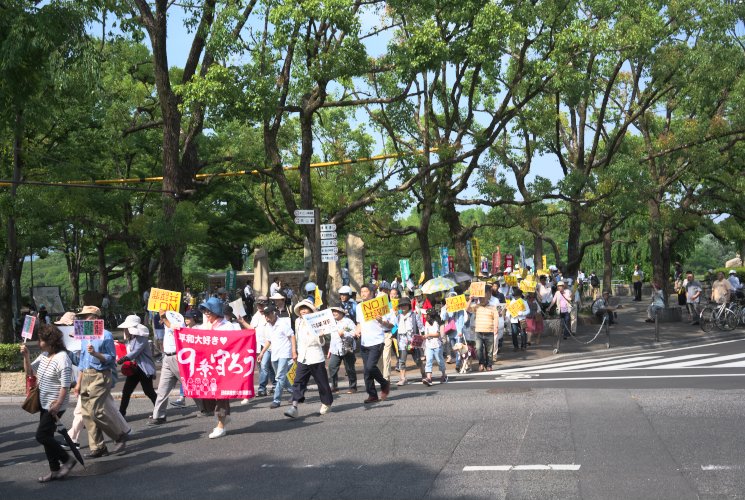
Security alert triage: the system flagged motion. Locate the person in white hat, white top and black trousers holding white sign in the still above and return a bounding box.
[285,299,334,418]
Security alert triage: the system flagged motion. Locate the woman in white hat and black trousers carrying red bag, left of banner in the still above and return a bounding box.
[116,314,158,416]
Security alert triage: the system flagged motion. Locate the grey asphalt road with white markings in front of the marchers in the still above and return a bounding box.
[0,340,745,500]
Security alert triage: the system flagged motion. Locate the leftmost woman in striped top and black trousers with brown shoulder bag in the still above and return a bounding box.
[21,324,77,483]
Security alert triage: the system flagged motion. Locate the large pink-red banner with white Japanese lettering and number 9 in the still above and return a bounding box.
[174,328,256,399]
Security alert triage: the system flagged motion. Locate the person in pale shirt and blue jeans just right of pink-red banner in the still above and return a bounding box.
[256,304,297,409]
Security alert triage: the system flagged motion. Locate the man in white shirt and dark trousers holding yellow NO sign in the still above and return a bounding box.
[356,284,393,404]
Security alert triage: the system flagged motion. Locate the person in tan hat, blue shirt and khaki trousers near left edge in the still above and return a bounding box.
[74,306,129,458]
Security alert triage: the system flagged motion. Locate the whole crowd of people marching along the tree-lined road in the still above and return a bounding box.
[21,268,742,482]
